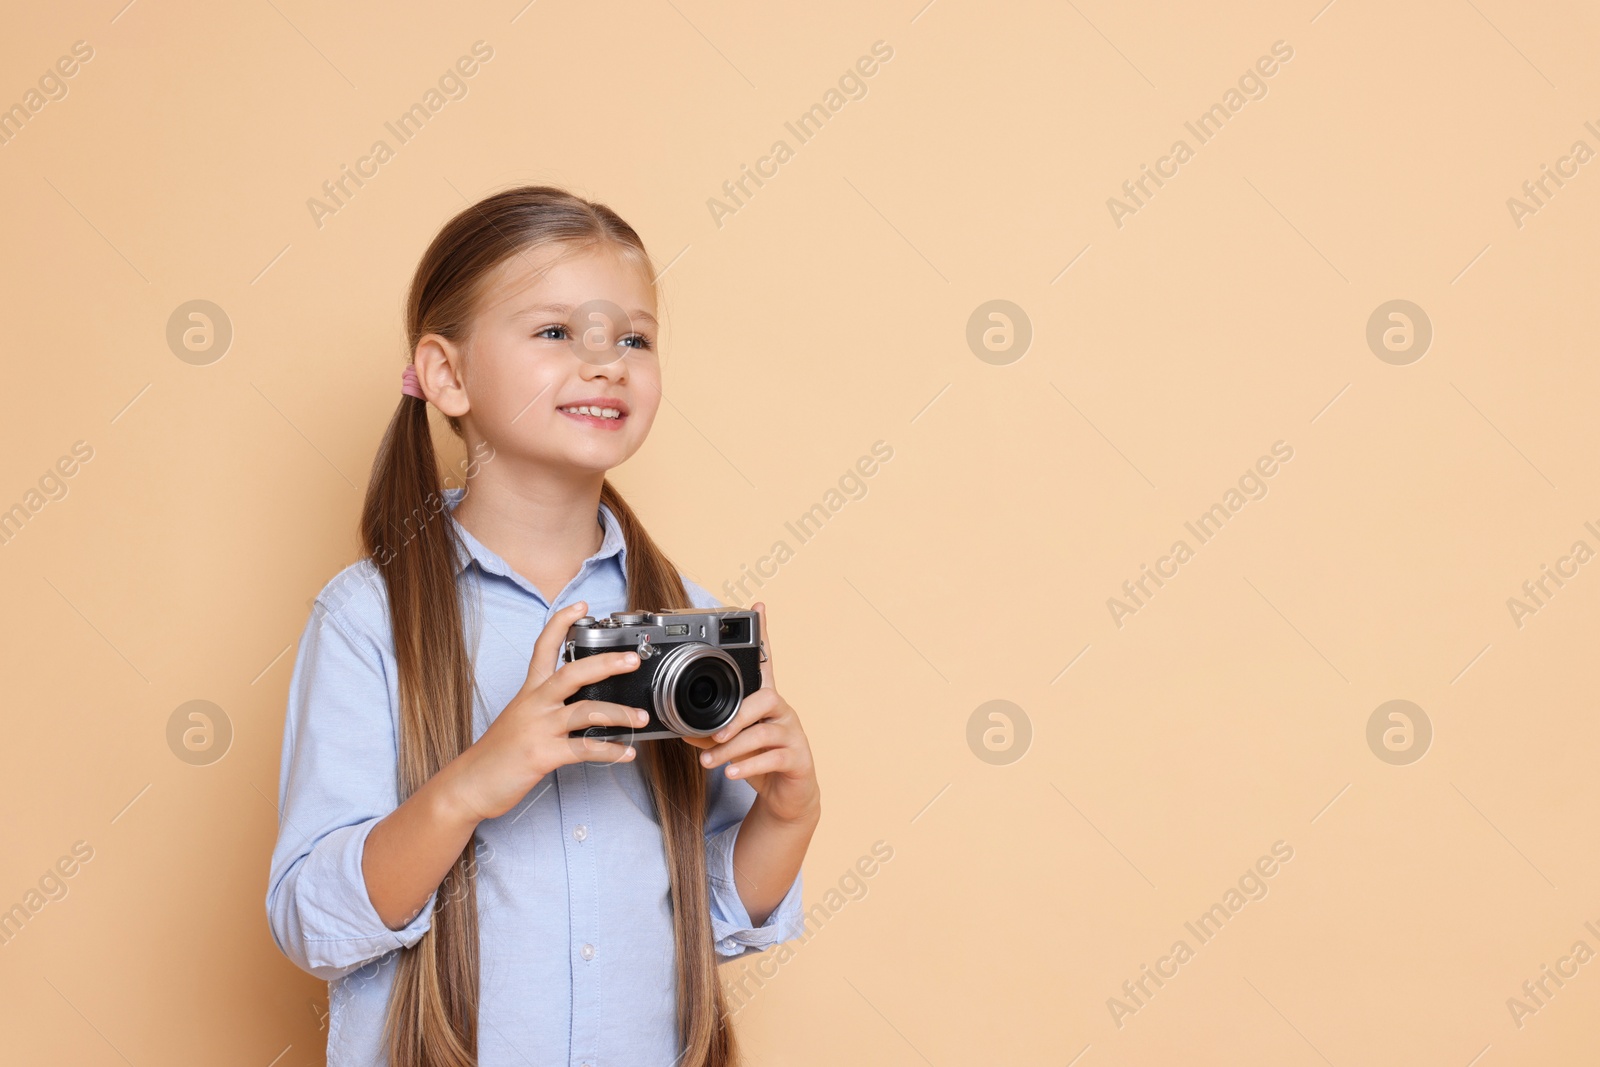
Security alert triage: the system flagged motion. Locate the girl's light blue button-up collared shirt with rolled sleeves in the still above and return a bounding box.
[267,488,803,1067]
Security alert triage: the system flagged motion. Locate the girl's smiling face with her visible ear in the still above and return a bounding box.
[416,243,661,474]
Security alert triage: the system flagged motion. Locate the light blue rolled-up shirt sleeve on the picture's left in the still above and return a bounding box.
[267,598,438,981]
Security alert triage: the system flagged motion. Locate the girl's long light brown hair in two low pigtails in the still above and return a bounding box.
[362,186,738,1067]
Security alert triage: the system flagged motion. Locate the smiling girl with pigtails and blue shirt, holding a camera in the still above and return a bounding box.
[267,187,821,1067]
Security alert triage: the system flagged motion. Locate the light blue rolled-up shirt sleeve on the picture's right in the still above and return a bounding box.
[683,577,805,960]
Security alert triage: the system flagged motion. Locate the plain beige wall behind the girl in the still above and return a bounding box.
[0,0,1600,1067]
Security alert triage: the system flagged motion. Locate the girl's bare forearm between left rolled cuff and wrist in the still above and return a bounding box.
[362,765,478,929]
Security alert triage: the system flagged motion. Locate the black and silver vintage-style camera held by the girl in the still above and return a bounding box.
[562,608,766,744]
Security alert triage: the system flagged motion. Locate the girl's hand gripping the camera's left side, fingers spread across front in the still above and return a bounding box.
[445,600,650,821]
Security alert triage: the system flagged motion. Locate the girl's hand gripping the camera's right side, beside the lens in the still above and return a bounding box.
[683,603,821,822]
